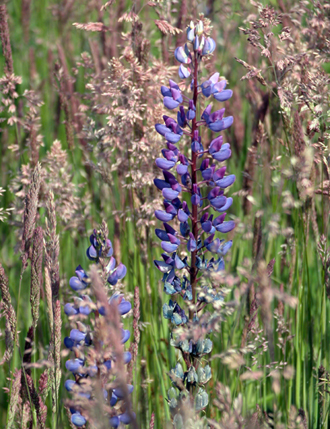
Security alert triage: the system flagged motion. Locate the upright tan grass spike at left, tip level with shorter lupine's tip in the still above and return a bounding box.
[30,226,43,328]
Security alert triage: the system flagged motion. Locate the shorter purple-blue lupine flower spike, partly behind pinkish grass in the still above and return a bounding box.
[64,228,135,428]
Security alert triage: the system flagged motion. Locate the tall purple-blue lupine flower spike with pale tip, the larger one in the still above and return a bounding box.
[154,21,235,427]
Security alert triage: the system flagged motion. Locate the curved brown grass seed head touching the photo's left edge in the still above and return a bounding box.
[0,263,17,365]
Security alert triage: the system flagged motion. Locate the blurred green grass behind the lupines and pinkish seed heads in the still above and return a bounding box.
[0,0,330,428]
